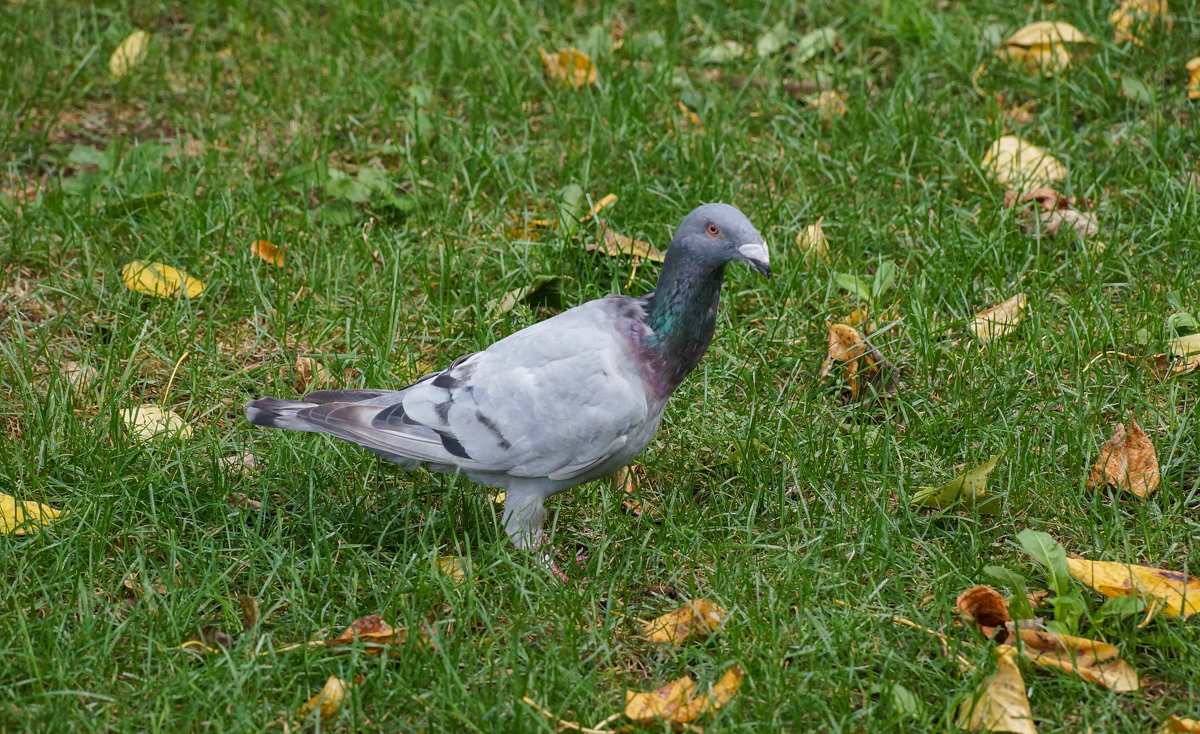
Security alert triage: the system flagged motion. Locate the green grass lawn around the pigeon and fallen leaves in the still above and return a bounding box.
[0,0,1200,733]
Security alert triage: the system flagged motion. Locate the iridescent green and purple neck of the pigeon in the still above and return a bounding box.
[647,253,725,395]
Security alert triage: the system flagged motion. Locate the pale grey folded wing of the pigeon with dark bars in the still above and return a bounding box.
[284,301,659,481]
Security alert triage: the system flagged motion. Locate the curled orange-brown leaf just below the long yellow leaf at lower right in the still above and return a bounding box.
[1006,625,1141,693]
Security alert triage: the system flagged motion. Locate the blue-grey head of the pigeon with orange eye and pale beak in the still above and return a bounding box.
[671,204,770,278]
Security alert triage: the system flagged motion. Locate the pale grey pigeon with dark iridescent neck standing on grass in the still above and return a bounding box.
[246,204,770,548]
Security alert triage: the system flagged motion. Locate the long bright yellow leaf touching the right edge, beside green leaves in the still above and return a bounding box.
[1067,558,1200,616]
